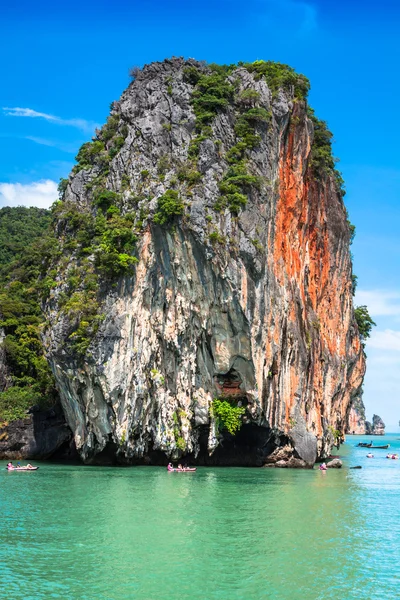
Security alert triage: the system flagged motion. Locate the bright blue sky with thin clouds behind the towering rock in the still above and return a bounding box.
[0,0,400,431]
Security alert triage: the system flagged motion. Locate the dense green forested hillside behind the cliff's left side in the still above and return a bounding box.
[0,207,56,422]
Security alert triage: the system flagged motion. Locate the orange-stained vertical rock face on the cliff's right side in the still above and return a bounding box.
[267,113,365,435]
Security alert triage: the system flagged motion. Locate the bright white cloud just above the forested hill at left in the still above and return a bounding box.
[0,179,58,208]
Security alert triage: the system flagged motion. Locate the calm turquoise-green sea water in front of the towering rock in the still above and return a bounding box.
[0,434,400,600]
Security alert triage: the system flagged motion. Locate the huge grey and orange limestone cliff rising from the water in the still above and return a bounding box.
[43,59,365,466]
